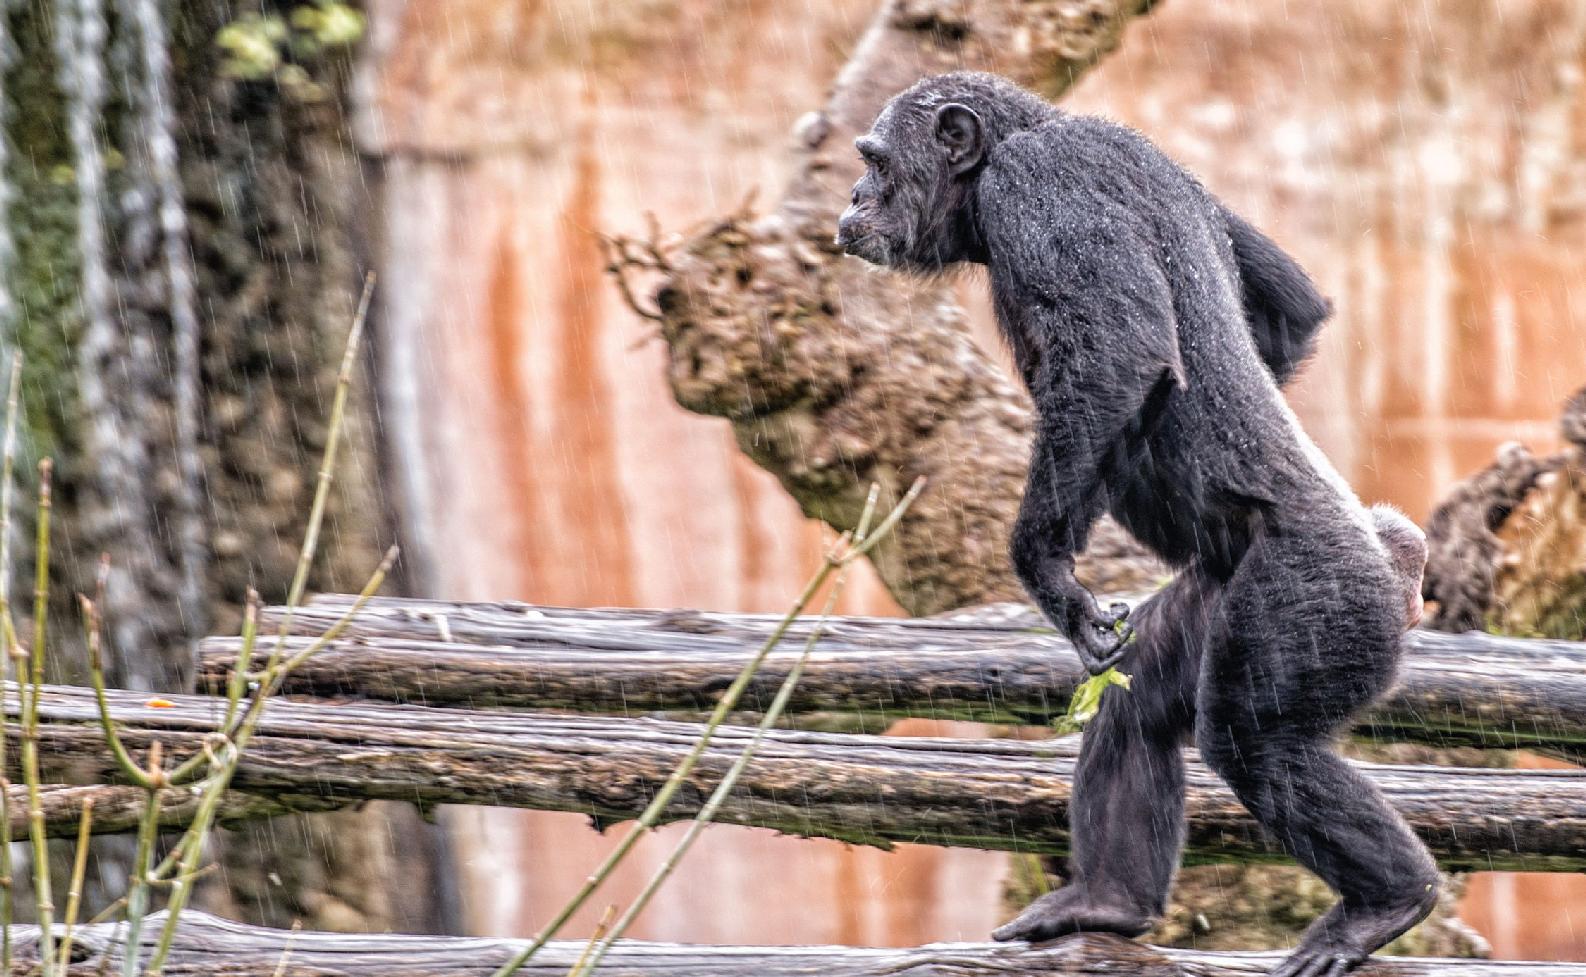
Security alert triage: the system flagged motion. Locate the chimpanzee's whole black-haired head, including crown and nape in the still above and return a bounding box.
[837,71,1055,273]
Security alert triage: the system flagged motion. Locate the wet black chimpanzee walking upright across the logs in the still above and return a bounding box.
[837,73,1439,977]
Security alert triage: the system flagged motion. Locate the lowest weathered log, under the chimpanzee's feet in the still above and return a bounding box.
[11,912,1586,977]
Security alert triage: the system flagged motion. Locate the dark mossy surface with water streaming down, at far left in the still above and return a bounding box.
[3,0,441,931]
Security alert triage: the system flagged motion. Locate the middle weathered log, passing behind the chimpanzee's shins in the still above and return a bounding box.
[11,687,1586,871]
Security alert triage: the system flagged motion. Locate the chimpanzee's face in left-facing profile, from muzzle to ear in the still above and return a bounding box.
[837,97,982,271]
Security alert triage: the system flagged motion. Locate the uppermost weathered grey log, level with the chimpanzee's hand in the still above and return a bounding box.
[200,596,1586,761]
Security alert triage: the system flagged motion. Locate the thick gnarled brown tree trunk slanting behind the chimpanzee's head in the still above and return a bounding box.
[619,0,1155,614]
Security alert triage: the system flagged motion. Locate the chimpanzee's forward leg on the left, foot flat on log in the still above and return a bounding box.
[993,568,1216,941]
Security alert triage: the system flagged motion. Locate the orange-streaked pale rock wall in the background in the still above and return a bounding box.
[357,0,1586,958]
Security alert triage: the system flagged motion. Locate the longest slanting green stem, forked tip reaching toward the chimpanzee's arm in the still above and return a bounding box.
[493,479,925,977]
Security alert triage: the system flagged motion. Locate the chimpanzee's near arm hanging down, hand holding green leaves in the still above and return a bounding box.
[980,164,1185,671]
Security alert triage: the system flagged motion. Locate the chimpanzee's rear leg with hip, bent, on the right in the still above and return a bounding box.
[1196,526,1439,977]
